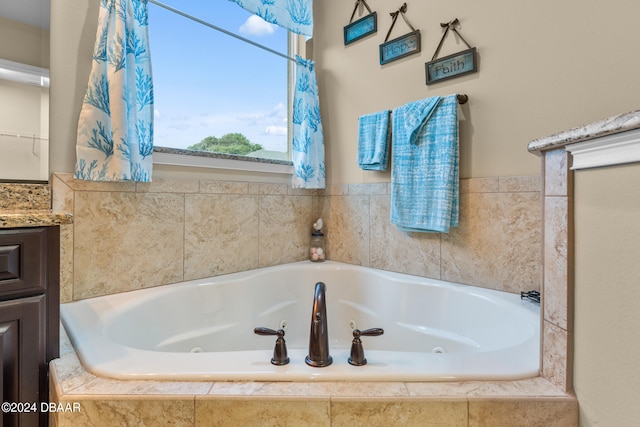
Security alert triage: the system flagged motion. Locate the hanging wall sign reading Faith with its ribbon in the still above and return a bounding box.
[424,18,478,85]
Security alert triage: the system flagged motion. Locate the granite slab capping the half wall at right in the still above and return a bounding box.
[528,110,640,155]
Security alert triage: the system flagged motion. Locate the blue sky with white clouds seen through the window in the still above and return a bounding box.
[149,0,289,151]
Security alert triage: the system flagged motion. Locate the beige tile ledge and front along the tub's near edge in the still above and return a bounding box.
[50,328,578,427]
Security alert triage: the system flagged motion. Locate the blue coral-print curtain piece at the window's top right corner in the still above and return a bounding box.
[229,0,313,37]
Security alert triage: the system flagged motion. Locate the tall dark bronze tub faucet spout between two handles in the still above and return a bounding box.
[305,282,333,368]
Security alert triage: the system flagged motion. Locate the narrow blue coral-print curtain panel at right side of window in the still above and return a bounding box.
[292,55,325,188]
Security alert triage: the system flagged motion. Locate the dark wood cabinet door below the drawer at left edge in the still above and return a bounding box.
[0,295,48,426]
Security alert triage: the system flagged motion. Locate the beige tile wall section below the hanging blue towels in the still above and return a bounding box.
[322,176,542,293]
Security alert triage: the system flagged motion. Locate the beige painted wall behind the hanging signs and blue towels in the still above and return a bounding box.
[313,0,640,184]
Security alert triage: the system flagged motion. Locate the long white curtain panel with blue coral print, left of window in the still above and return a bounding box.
[75,0,153,182]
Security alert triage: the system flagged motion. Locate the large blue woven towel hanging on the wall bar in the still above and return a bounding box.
[391,95,459,233]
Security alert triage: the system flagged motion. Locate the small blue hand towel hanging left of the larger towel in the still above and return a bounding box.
[358,110,391,171]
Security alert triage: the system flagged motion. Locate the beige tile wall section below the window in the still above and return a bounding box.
[52,174,320,302]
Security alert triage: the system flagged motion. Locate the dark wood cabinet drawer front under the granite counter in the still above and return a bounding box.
[0,228,47,299]
